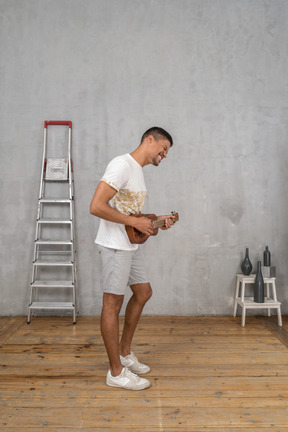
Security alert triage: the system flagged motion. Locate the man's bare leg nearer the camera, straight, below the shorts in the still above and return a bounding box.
[101,293,124,376]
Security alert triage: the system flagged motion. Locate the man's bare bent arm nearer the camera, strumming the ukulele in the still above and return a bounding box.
[90,181,153,235]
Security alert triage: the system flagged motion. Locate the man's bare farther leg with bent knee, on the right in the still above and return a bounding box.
[120,283,152,357]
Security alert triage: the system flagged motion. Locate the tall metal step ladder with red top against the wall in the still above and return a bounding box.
[27,121,78,324]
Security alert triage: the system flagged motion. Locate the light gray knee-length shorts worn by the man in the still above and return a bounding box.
[98,245,148,295]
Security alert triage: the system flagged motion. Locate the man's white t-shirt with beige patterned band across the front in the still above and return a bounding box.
[95,153,147,250]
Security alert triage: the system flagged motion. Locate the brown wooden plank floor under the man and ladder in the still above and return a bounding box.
[0,317,288,432]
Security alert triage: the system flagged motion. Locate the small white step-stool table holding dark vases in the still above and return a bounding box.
[233,274,282,327]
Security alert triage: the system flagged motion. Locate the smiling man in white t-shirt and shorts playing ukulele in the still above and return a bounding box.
[90,127,173,390]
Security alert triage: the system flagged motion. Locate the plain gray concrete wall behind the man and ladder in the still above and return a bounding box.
[0,0,288,315]
